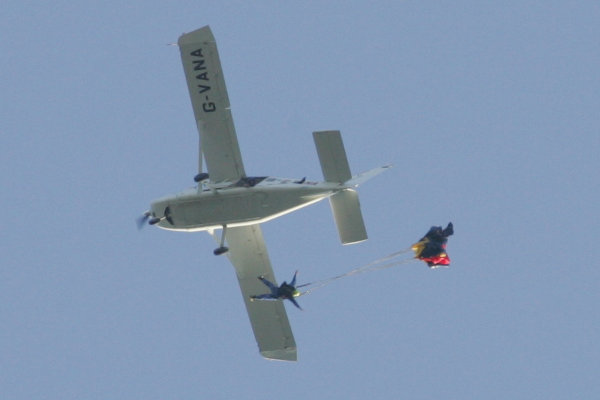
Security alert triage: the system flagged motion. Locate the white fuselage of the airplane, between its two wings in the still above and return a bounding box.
[151,177,346,232]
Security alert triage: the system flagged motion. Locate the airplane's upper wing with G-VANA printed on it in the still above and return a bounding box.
[177,26,245,182]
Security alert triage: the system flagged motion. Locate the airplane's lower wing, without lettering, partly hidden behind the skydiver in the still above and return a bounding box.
[227,225,296,361]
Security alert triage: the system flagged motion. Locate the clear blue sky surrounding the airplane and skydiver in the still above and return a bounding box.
[0,0,600,400]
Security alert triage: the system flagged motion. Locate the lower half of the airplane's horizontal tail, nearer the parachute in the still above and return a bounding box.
[329,189,367,244]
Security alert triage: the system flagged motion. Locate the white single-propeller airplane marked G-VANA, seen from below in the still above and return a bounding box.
[140,26,389,361]
